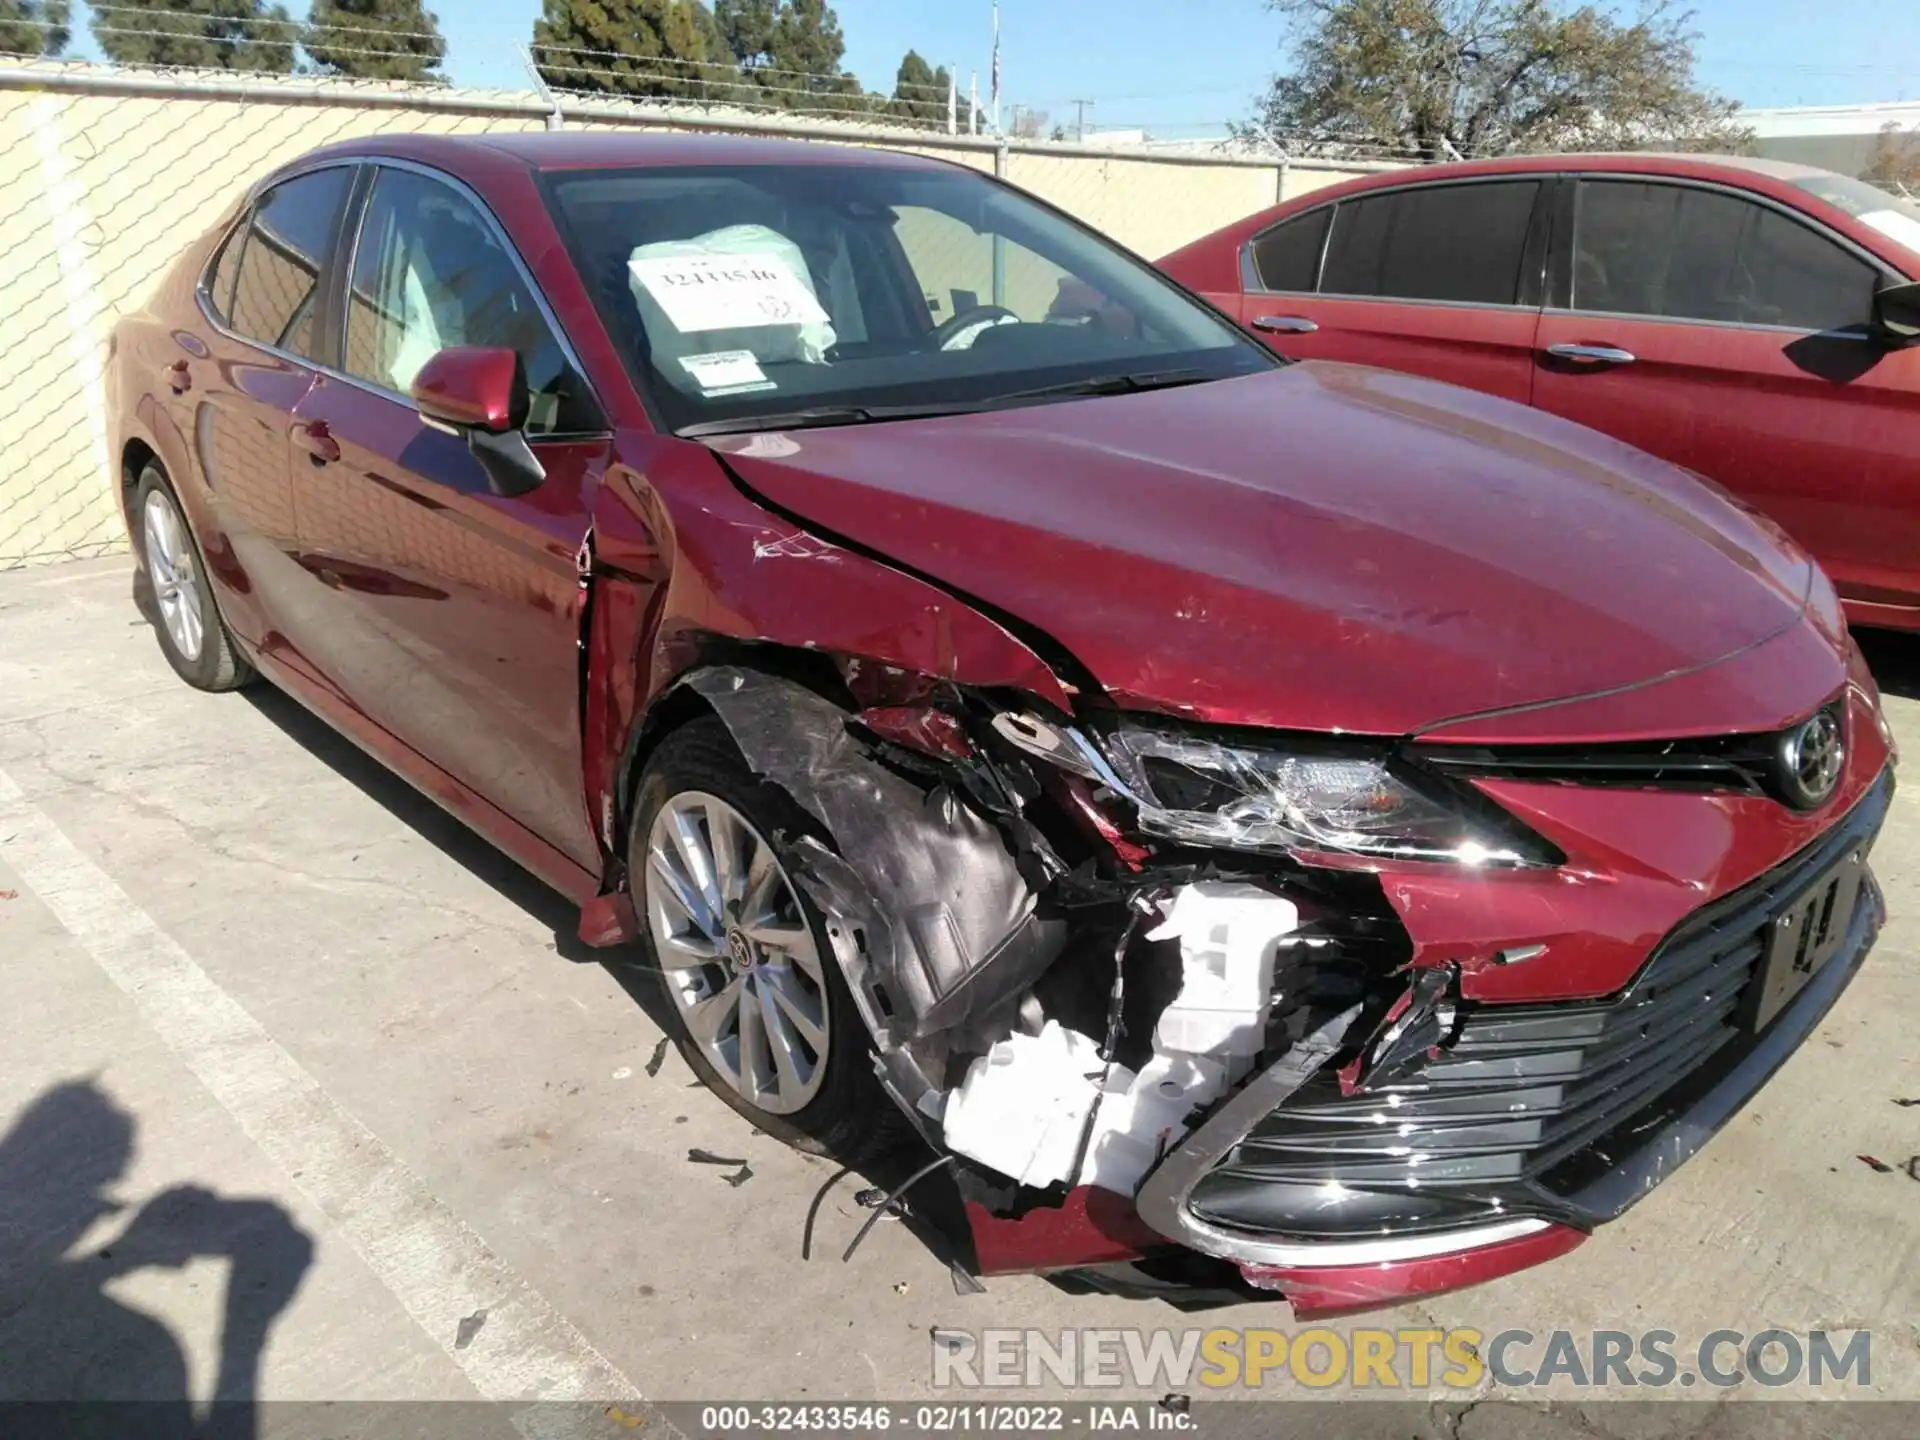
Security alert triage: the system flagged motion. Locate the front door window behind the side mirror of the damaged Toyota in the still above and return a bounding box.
[346,169,597,434]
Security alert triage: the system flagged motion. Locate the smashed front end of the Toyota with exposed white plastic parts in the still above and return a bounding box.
[684,666,1889,1315]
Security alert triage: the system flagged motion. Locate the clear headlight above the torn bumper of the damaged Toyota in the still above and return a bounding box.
[1106,726,1559,866]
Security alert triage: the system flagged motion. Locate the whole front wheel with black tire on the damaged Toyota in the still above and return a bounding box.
[628,718,895,1162]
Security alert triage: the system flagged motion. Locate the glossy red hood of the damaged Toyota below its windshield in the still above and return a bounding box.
[714,363,1812,735]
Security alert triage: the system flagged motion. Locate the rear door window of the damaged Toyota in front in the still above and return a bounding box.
[228,165,353,357]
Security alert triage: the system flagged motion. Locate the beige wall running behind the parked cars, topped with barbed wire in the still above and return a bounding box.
[0,73,1397,568]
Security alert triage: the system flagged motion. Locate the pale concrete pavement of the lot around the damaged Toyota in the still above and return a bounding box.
[0,559,1920,1436]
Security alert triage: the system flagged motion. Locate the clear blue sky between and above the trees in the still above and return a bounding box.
[60,0,1920,136]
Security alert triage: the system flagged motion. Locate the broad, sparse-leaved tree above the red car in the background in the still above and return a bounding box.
[1236,0,1745,159]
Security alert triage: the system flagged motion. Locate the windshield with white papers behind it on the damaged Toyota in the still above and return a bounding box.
[549,165,1279,430]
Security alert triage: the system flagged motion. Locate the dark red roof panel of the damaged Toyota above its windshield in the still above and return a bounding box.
[284,131,950,173]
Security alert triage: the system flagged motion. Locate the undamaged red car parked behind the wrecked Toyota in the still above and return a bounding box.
[1160,156,1920,630]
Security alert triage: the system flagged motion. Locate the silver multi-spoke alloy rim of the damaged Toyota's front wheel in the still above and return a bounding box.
[645,791,829,1116]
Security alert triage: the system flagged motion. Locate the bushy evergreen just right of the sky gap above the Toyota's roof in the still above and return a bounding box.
[534,0,726,98]
